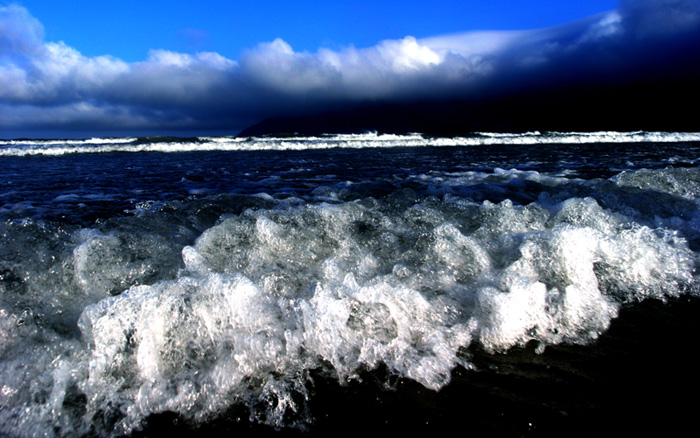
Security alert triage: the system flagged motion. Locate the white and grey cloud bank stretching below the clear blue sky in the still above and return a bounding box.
[0,0,700,137]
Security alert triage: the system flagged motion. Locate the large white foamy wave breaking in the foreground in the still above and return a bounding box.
[0,169,700,436]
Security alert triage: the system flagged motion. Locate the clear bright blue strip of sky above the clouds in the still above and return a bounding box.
[15,0,618,62]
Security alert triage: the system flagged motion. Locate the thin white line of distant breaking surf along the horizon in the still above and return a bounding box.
[0,131,700,157]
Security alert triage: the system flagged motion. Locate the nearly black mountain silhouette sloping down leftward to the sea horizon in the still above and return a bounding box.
[239,76,700,136]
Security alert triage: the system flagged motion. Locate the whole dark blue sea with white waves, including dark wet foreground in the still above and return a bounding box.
[0,132,700,437]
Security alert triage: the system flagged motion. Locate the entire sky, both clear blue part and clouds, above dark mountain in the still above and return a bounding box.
[0,0,700,138]
